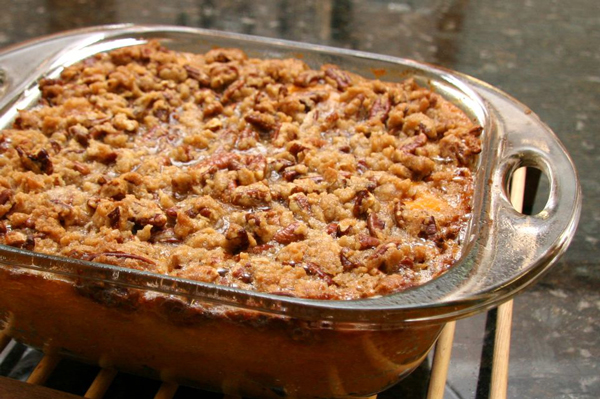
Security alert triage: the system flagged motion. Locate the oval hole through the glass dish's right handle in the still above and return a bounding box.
[506,166,550,215]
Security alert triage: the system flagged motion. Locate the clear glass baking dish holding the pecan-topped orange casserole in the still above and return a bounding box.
[0,25,581,397]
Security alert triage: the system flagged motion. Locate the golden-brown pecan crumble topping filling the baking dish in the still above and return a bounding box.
[0,42,482,299]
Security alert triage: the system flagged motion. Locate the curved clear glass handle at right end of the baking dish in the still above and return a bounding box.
[476,84,581,294]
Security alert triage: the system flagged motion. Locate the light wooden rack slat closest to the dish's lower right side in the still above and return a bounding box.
[427,321,456,399]
